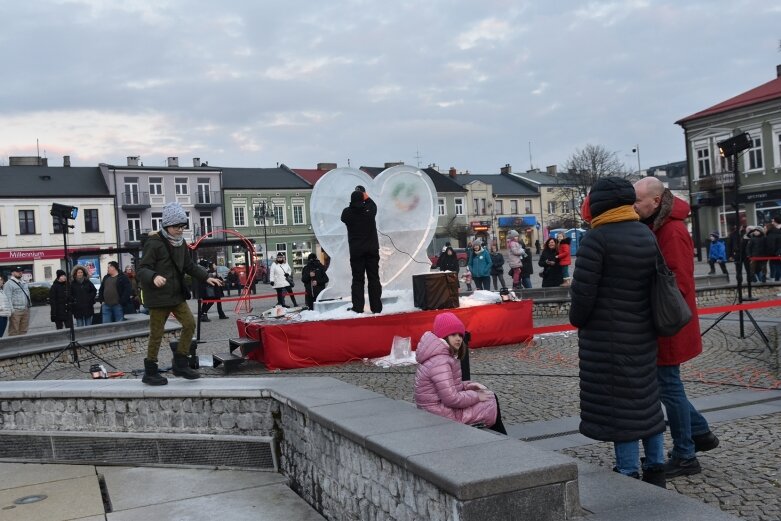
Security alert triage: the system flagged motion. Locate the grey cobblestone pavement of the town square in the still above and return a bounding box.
[12,265,781,521]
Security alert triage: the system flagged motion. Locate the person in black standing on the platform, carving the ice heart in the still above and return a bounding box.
[342,185,382,313]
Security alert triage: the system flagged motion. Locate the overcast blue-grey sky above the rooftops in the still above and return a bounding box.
[0,0,781,174]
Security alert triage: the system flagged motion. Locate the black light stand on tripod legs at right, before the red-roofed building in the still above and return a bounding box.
[701,132,770,350]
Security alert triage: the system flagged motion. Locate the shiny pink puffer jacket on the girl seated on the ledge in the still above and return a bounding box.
[415,331,496,427]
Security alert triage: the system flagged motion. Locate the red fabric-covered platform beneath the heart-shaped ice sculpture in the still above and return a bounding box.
[238,300,533,369]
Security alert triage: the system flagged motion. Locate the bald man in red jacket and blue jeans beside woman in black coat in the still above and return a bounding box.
[635,177,719,478]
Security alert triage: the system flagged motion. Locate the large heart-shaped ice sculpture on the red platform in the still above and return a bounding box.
[310,165,437,300]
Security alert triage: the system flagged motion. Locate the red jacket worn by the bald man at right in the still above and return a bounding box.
[655,197,702,365]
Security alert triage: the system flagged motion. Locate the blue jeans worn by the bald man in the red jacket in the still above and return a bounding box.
[656,365,710,459]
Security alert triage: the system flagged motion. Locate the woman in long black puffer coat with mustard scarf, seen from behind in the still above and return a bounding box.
[569,177,665,486]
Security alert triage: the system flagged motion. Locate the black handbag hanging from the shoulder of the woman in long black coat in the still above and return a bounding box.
[651,243,692,336]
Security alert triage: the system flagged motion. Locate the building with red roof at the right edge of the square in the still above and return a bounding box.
[676,65,781,245]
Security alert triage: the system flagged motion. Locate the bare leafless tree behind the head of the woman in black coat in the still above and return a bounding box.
[550,144,631,228]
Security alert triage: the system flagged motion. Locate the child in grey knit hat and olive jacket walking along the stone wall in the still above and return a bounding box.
[136,203,222,385]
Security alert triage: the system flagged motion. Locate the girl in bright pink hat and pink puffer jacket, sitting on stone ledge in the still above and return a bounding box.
[415,313,507,434]
